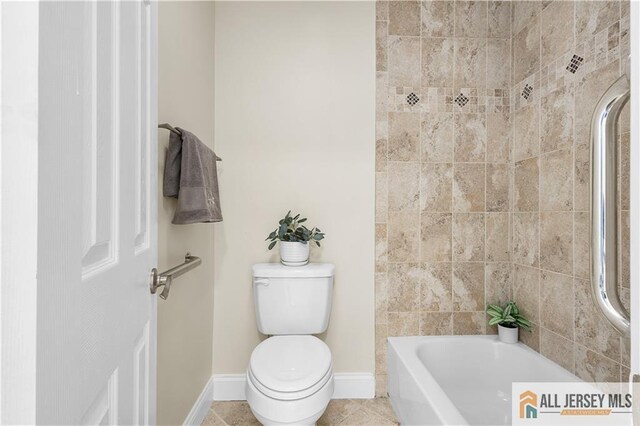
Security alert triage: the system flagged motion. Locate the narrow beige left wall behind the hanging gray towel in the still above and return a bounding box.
[157,2,218,425]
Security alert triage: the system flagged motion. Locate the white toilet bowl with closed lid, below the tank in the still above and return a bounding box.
[245,335,334,425]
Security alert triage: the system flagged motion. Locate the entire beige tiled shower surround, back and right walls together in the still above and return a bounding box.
[376,1,629,395]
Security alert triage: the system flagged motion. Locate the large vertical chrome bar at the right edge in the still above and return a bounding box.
[590,71,630,336]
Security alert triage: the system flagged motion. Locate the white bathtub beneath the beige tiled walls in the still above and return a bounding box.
[388,336,580,425]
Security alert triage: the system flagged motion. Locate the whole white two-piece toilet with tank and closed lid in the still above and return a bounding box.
[245,263,334,425]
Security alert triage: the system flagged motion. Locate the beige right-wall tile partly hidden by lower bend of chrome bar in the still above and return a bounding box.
[574,279,620,360]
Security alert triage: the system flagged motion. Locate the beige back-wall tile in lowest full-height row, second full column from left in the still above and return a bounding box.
[420,262,453,312]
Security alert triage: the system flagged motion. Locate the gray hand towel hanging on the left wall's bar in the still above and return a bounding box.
[163,128,222,224]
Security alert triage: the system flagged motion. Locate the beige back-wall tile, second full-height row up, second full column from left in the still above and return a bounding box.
[416,213,452,262]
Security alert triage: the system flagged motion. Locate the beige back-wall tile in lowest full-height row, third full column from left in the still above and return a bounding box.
[452,262,485,312]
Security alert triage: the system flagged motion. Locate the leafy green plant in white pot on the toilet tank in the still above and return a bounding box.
[266,210,324,266]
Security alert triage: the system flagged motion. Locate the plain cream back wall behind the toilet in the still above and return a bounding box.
[213,2,375,374]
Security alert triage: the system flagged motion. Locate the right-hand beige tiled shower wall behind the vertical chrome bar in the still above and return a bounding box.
[512,0,629,381]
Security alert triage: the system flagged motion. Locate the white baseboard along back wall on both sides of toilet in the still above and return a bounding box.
[213,373,376,401]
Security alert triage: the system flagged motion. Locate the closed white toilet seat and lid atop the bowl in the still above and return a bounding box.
[247,335,333,401]
